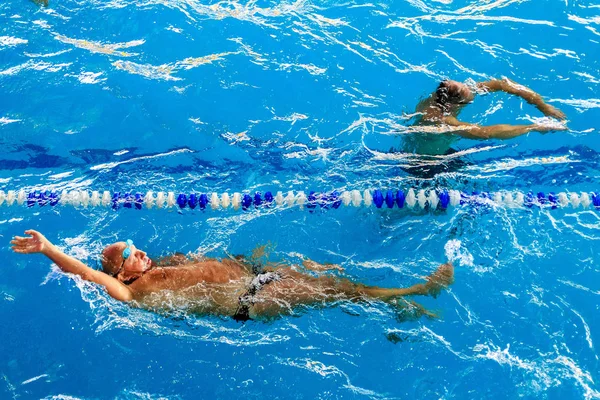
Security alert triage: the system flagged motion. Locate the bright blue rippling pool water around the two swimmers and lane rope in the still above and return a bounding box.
[0,0,600,399]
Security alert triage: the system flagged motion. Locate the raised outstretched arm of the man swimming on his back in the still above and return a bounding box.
[10,229,133,301]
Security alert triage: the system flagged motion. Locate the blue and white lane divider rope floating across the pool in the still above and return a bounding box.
[0,188,600,211]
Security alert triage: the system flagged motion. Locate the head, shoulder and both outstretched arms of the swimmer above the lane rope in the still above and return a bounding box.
[417,79,567,139]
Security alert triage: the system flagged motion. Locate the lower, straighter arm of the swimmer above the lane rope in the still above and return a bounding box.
[443,117,567,140]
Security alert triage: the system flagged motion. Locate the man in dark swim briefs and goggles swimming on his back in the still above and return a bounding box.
[10,230,454,321]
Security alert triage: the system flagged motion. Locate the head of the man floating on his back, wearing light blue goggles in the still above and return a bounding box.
[102,241,152,282]
